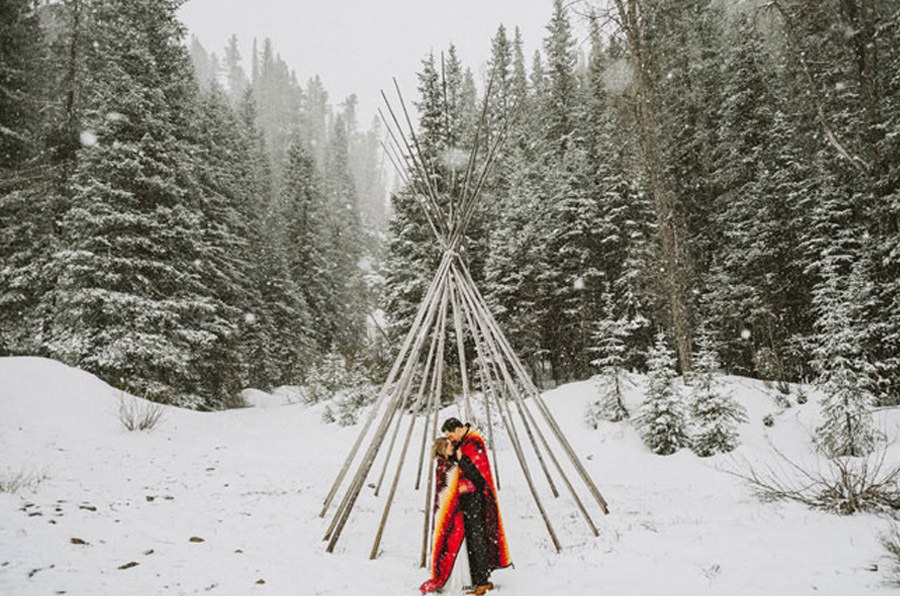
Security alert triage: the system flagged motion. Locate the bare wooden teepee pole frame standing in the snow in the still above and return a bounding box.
[319,70,609,567]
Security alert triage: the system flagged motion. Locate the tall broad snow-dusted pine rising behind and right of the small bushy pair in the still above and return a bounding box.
[704,15,812,387]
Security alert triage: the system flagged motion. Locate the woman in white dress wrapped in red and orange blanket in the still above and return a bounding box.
[419,437,475,594]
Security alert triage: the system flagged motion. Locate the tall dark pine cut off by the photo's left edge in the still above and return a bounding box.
[0,0,58,356]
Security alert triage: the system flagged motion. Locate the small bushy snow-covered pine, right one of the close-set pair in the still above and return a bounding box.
[689,331,747,457]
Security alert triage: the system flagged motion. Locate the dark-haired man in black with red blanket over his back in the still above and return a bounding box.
[441,418,510,596]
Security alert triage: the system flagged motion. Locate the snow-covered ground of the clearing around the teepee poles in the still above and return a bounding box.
[0,358,900,596]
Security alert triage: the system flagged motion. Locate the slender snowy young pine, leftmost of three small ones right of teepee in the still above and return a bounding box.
[587,292,631,428]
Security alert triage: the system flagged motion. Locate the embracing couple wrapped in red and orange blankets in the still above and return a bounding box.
[419,418,510,596]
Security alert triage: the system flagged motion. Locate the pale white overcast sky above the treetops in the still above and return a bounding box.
[180,0,552,128]
